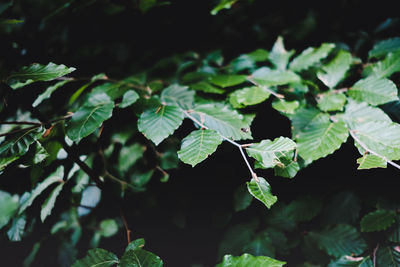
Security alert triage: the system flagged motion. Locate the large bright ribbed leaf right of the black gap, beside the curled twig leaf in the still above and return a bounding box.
[296,118,349,161]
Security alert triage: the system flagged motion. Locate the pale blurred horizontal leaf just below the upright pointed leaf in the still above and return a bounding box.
[250,67,301,86]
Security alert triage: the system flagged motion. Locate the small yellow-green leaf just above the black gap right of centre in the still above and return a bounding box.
[229,86,271,108]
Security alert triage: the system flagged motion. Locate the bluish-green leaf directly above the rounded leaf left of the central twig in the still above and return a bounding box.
[161,84,195,110]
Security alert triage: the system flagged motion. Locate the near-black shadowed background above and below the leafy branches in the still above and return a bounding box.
[0,0,399,267]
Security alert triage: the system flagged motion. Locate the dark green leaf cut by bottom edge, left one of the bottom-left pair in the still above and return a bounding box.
[72,248,119,267]
